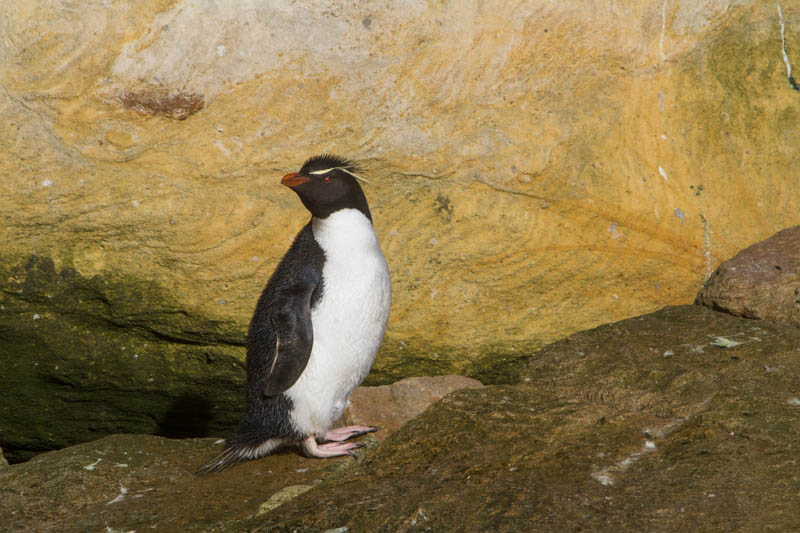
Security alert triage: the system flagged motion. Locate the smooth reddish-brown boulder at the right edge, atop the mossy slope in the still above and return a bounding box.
[695,226,800,326]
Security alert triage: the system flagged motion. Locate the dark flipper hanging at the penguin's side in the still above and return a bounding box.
[264,283,315,396]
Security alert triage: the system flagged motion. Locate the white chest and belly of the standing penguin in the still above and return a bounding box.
[287,209,391,434]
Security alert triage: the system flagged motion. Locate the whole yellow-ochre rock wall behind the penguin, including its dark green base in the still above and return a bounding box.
[0,0,800,458]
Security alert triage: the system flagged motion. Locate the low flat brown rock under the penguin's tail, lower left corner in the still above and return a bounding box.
[0,435,354,532]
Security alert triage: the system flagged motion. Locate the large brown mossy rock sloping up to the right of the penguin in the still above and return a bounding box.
[256,306,800,532]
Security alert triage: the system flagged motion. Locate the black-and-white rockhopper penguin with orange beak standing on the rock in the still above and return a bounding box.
[197,155,391,475]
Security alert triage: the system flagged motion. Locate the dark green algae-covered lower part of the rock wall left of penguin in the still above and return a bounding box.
[0,256,244,461]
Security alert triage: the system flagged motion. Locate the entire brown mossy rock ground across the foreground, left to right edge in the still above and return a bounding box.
[0,306,800,532]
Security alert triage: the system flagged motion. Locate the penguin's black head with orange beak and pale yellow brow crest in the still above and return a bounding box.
[281,155,372,221]
